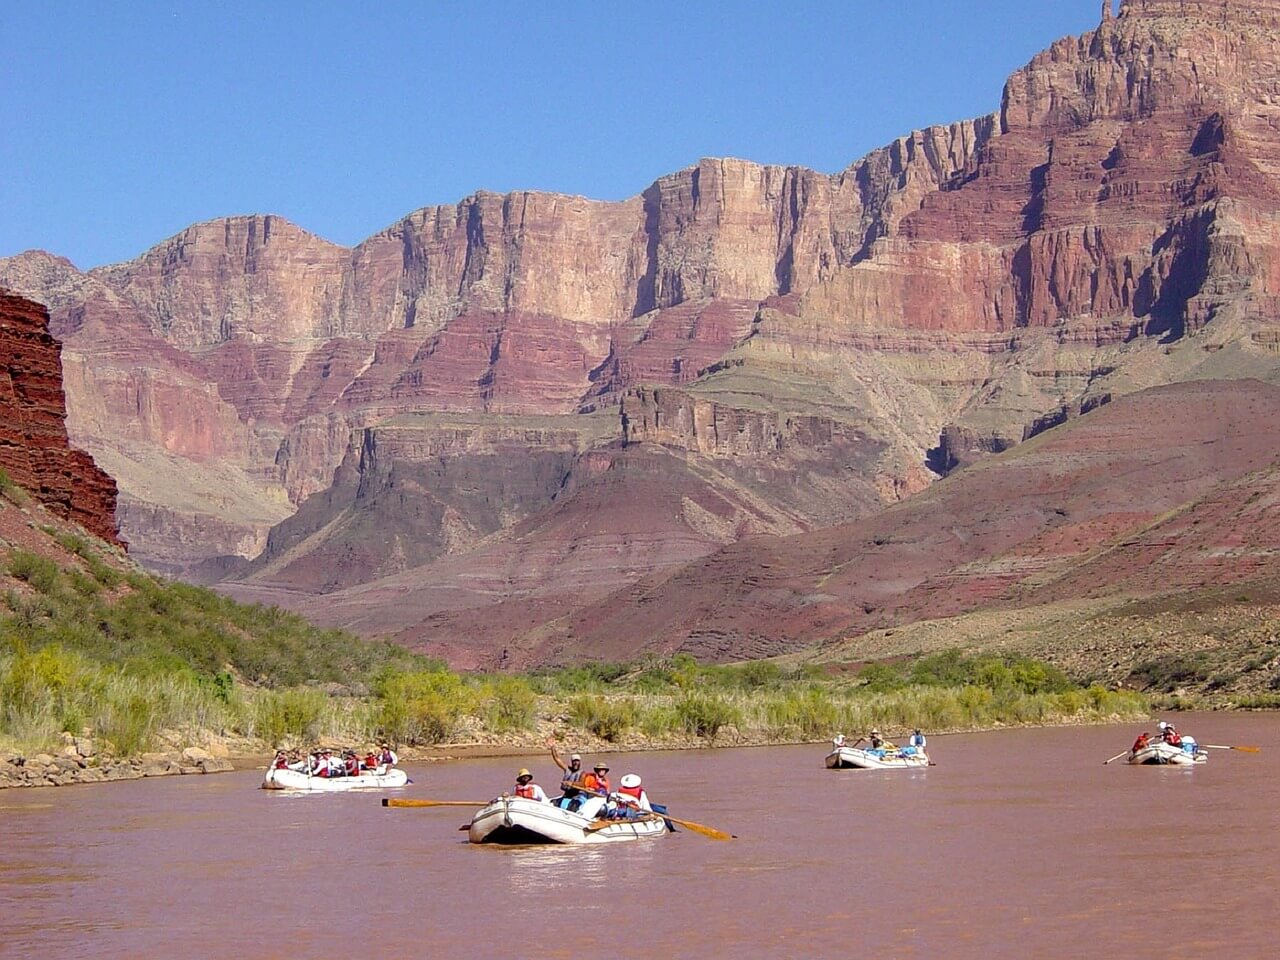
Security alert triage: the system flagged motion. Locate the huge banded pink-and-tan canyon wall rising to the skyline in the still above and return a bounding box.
[0,0,1280,655]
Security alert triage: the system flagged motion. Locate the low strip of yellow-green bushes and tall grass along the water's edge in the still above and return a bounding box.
[0,640,1149,786]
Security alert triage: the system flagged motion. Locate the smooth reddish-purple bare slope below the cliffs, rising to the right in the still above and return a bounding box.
[285,380,1280,667]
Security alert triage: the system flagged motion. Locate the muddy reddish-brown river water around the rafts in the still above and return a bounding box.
[0,714,1280,960]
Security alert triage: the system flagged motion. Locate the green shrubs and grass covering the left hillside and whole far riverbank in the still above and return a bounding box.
[0,527,1152,756]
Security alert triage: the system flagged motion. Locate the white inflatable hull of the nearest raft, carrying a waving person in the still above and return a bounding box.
[467,796,667,844]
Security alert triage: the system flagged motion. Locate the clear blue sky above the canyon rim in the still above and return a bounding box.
[0,0,1101,269]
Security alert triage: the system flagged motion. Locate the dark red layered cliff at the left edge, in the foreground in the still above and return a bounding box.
[0,291,119,544]
